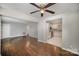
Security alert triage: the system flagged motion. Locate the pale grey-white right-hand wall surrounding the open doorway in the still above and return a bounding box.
[38,13,79,53]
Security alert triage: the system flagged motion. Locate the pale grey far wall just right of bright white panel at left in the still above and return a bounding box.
[10,23,26,37]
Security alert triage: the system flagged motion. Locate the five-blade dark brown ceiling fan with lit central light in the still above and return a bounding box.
[30,3,56,17]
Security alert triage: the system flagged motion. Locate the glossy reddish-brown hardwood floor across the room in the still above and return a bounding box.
[1,36,77,56]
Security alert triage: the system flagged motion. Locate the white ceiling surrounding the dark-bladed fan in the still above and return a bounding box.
[0,3,79,19]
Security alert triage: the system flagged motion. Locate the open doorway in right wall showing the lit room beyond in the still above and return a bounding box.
[47,19,62,47]
